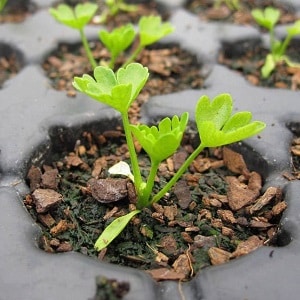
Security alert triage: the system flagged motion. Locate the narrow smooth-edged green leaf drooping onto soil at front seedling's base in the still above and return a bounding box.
[95,210,140,251]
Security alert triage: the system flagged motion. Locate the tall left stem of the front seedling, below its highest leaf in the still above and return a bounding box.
[121,113,143,193]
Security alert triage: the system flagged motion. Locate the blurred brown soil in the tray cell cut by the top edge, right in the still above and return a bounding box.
[186,0,297,25]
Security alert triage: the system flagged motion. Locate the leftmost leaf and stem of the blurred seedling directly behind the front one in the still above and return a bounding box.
[49,2,98,69]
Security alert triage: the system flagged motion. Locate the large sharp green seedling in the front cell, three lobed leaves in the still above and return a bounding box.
[73,63,266,251]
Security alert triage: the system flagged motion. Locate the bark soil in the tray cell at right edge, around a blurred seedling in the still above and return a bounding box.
[218,40,300,91]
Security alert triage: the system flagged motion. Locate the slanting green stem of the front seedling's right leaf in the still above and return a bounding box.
[150,143,205,204]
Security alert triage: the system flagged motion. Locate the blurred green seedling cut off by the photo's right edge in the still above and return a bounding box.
[251,7,300,78]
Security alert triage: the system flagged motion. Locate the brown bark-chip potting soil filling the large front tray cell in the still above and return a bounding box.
[24,129,286,281]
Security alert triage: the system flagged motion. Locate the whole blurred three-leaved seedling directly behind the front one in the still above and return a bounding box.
[50,0,174,69]
